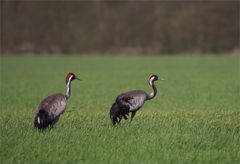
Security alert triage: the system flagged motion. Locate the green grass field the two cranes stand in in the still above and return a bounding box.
[0,56,240,163]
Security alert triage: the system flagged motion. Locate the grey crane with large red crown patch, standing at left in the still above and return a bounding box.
[34,73,80,130]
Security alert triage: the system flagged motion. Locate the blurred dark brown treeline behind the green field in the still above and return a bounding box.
[1,0,240,54]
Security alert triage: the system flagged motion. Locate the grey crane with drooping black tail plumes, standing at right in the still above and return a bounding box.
[110,75,164,125]
